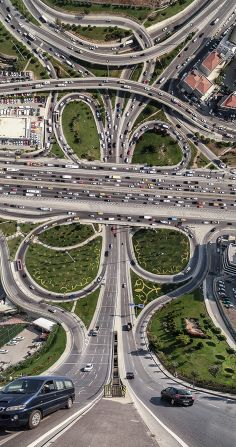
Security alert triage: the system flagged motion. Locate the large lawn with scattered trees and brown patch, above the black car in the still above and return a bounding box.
[149,289,236,393]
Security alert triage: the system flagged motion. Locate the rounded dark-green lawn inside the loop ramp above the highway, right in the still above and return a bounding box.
[132,131,182,166]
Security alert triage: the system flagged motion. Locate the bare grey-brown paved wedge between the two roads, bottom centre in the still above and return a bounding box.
[48,397,159,447]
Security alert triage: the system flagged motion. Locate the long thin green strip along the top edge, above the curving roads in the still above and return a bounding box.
[41,0,151,21]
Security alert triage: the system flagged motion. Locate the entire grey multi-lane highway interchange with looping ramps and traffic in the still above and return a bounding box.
[0,0,236,447]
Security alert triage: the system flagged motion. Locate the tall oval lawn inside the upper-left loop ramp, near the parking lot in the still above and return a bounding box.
[62,101,100,161]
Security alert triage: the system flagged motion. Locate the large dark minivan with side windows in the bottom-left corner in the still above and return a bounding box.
[0,376,75,429]
